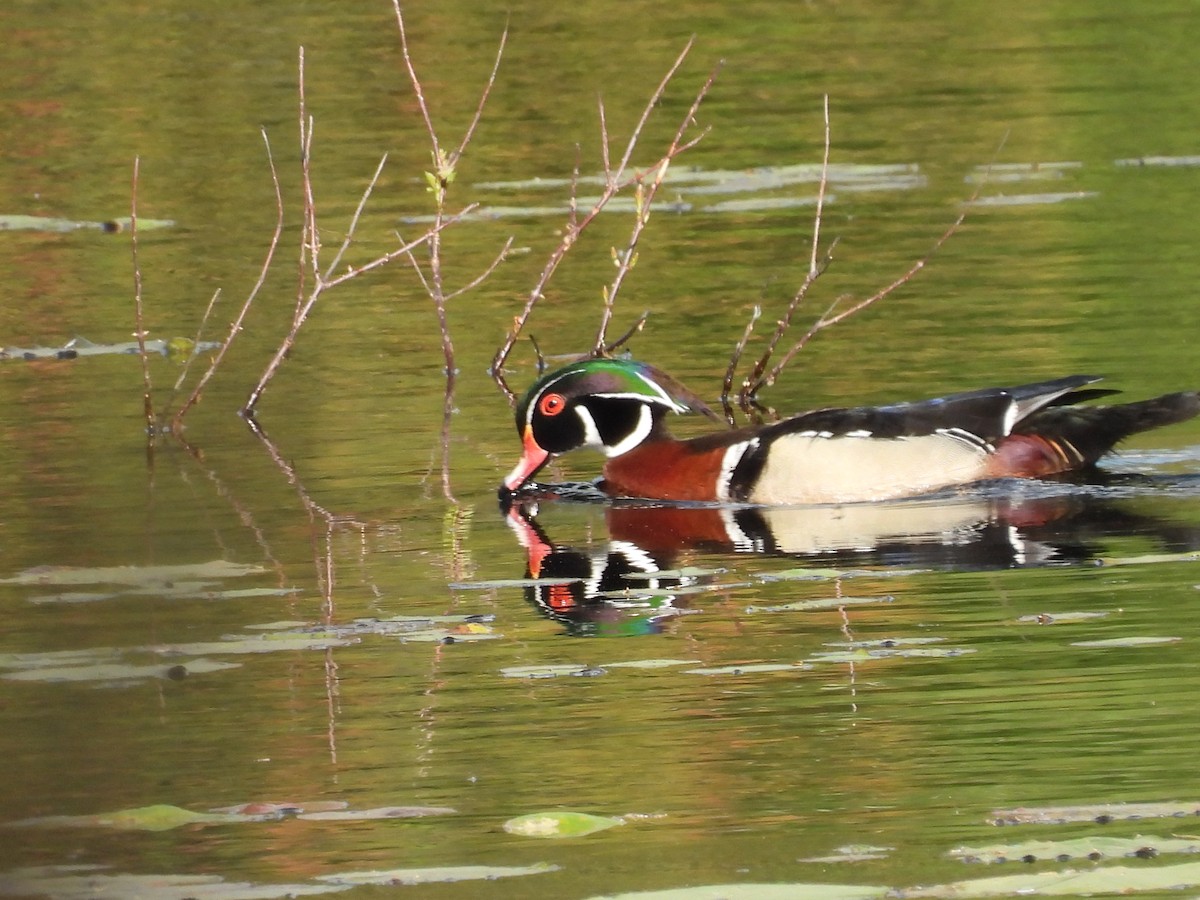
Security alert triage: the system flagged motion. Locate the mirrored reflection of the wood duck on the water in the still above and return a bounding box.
[505,485,1200,635]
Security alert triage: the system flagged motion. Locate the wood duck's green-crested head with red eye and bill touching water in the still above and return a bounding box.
[499,359,708,502]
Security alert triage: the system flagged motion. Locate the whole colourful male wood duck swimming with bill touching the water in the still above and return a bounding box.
[499,359,1200,505]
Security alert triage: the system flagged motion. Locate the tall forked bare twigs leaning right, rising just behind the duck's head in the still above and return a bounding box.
[491,37,716,403]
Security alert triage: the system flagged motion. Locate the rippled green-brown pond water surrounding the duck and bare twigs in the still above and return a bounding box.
[0,0,1200,898]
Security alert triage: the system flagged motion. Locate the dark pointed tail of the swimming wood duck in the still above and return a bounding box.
[1013,391,1200,466]
